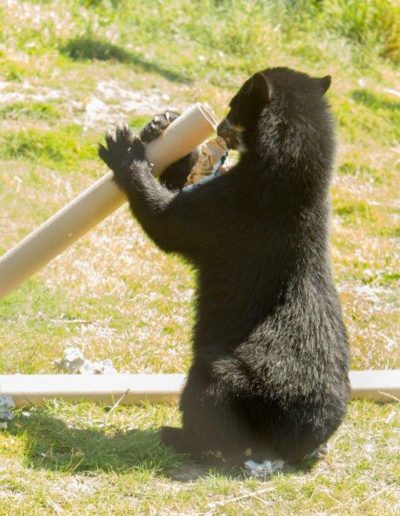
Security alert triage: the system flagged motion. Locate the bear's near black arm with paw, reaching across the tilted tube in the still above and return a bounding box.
[99,126,235,260]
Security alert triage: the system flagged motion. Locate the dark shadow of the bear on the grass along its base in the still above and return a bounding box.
[9,408,316,482]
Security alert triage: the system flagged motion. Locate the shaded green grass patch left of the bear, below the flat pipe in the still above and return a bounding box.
[10,407,177,473]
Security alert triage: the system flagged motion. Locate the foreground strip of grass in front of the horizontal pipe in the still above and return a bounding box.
[0,402,400,515]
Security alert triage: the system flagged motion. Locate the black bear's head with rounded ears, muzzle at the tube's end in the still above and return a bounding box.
[217,67,332,164]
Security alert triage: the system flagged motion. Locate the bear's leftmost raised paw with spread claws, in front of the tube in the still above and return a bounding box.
[99,124,148,187]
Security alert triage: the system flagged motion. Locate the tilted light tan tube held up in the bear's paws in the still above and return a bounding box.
[0,104,216,298]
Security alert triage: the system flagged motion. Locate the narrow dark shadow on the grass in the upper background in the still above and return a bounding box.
[60,36,191,84]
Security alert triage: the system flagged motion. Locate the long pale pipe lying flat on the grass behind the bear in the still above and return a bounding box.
[0,369,400,407]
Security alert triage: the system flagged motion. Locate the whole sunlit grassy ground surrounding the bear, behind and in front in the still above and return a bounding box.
[0,0,400,515]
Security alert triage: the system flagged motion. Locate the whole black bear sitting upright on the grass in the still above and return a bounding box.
[99,68,350,474]
